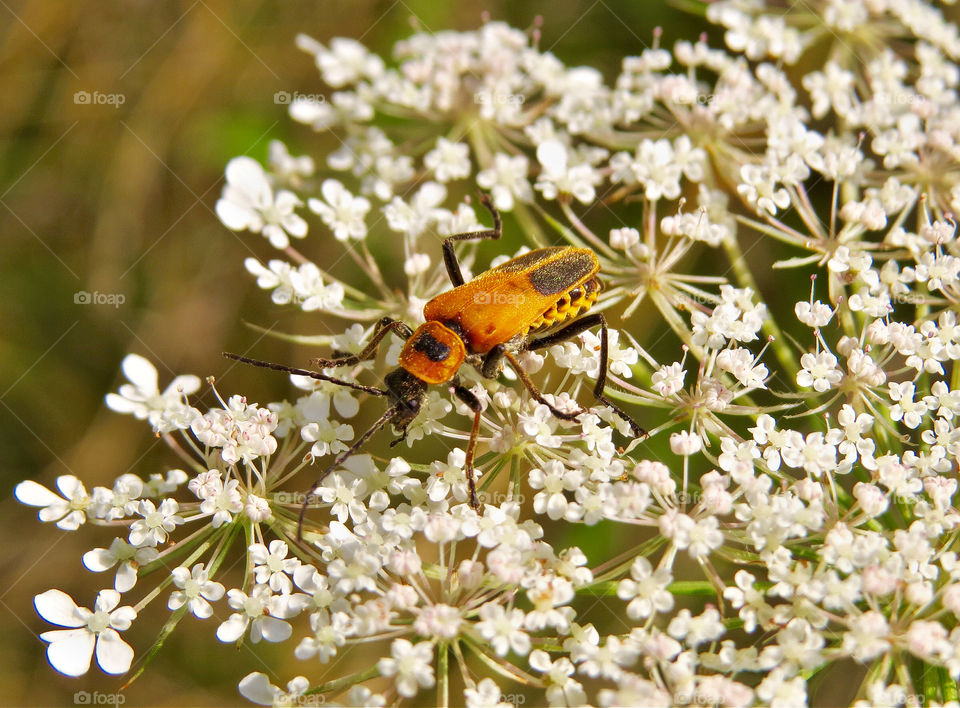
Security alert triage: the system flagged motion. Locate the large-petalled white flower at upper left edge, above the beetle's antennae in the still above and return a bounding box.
[216,157,307,248]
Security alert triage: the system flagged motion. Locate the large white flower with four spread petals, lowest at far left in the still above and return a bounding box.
[33,590,137,676]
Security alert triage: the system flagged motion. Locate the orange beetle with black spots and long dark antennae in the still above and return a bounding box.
[224,194,646,538]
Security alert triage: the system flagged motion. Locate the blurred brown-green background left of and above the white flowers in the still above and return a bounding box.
[0,0,744,705]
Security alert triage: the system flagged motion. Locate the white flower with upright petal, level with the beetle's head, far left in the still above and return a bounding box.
[105,354,200,433]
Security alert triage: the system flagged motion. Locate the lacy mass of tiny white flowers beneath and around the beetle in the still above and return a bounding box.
[16,0,960,706]
